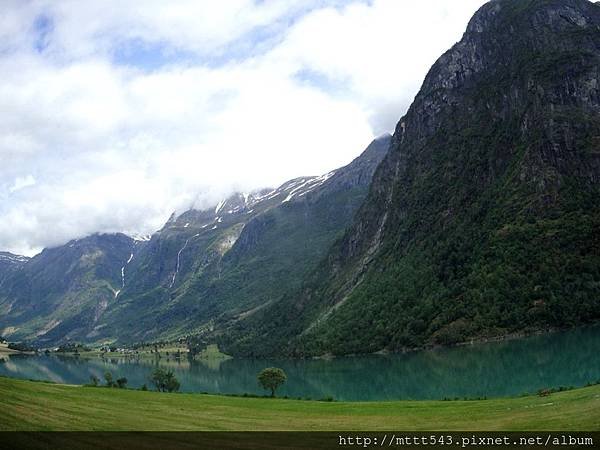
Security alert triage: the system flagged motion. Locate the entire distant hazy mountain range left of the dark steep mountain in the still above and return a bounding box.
[0,136,391,346]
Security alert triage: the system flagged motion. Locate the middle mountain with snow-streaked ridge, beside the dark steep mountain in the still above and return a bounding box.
[99,136,390,342]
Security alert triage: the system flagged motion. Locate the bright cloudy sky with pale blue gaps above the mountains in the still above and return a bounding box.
[0,0,484,255]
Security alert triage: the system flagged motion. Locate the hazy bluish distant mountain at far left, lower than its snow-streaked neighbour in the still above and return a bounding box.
[0,234,135,343]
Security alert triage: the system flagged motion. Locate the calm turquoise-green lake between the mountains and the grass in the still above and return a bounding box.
[0,326,600,401]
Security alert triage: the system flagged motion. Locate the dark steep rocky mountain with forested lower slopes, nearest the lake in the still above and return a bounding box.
[218,0,600,356]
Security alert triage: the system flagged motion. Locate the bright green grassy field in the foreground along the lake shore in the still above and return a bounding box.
[0,377,600,431]
